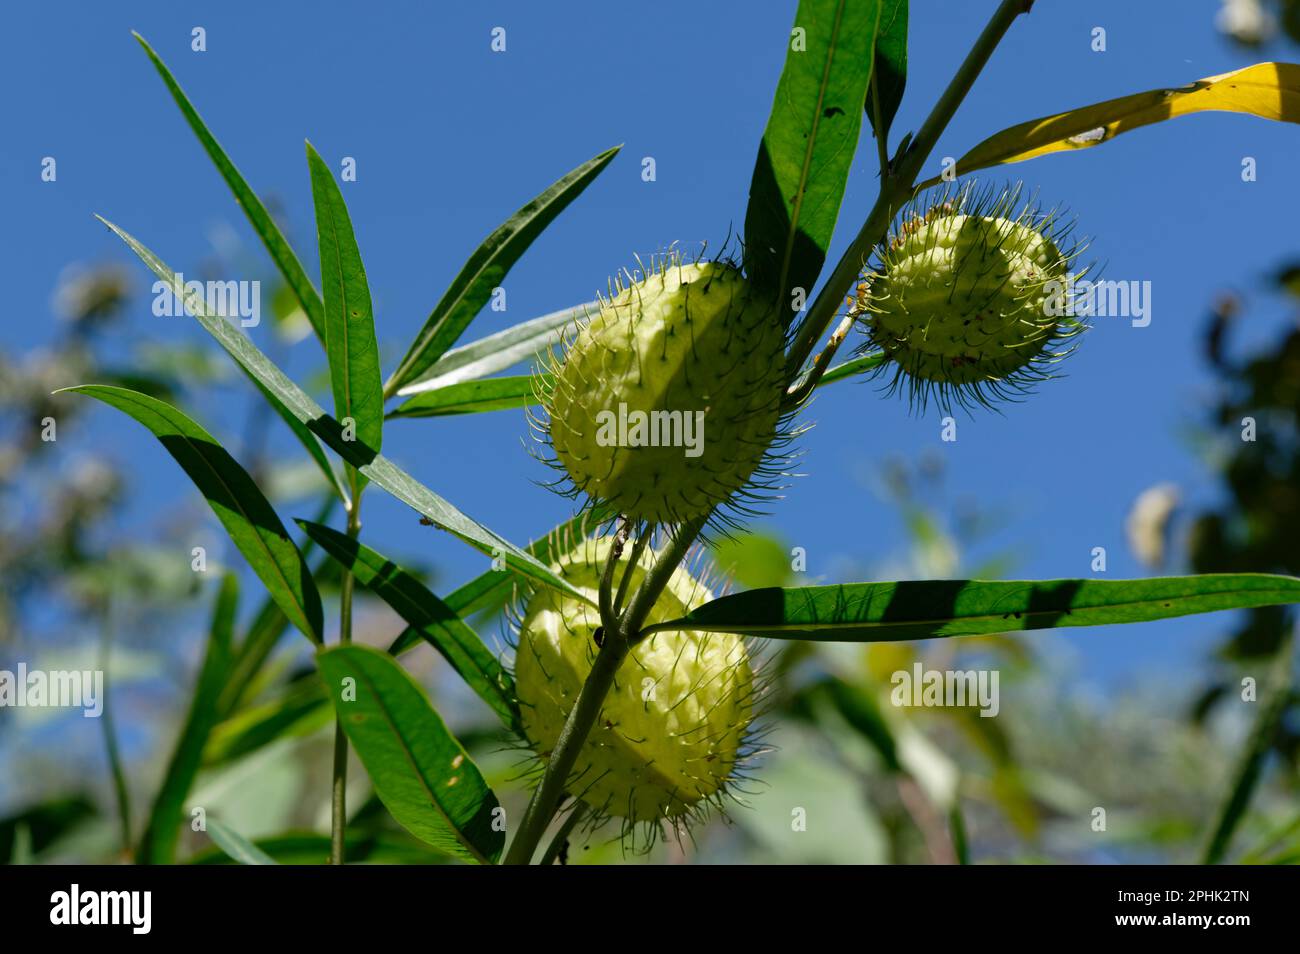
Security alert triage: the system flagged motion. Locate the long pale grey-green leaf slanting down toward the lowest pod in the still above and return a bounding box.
[99,217,590,602]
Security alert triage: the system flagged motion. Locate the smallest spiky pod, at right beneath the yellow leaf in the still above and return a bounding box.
[857,188,1083,407]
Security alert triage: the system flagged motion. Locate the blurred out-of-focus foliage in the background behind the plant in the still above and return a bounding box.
[0,0,1300,863]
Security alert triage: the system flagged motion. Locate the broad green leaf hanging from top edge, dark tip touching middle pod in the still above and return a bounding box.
[745,0,881,298]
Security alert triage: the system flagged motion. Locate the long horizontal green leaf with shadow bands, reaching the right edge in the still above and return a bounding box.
[650,573,1300,642]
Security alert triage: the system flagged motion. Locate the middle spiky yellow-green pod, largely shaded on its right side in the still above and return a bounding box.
[541,256,785,524]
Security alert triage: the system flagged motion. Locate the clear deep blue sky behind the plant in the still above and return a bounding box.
[0,0,1300,696]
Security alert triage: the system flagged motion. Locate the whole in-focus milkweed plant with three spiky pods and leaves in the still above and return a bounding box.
[69,0,1300,864]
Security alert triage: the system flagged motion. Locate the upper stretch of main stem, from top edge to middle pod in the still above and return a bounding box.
[787,0,1034,382]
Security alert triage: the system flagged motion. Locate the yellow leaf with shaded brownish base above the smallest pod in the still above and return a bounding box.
[922,62,1300,188]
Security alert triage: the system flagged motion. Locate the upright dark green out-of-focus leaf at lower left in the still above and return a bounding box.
[135,573,239,864]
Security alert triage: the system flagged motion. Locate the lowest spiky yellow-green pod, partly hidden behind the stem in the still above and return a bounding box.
[515,538,754,823]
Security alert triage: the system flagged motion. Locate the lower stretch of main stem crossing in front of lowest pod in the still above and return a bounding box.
[506,511,711,864]
